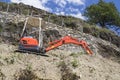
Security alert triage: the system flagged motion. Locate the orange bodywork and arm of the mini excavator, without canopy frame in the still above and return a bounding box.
[20,36,93,55]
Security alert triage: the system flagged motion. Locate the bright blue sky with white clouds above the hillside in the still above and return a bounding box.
[0,0,120,35]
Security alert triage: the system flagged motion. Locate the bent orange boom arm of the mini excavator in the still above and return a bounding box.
[45,36,93,55]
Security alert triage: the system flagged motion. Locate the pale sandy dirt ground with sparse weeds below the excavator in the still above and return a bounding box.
[0,40,120,80]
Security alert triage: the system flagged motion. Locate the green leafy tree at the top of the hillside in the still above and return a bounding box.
[84,0,120,27]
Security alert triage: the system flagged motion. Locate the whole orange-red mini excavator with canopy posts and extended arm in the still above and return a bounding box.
[18,18,93,55]
